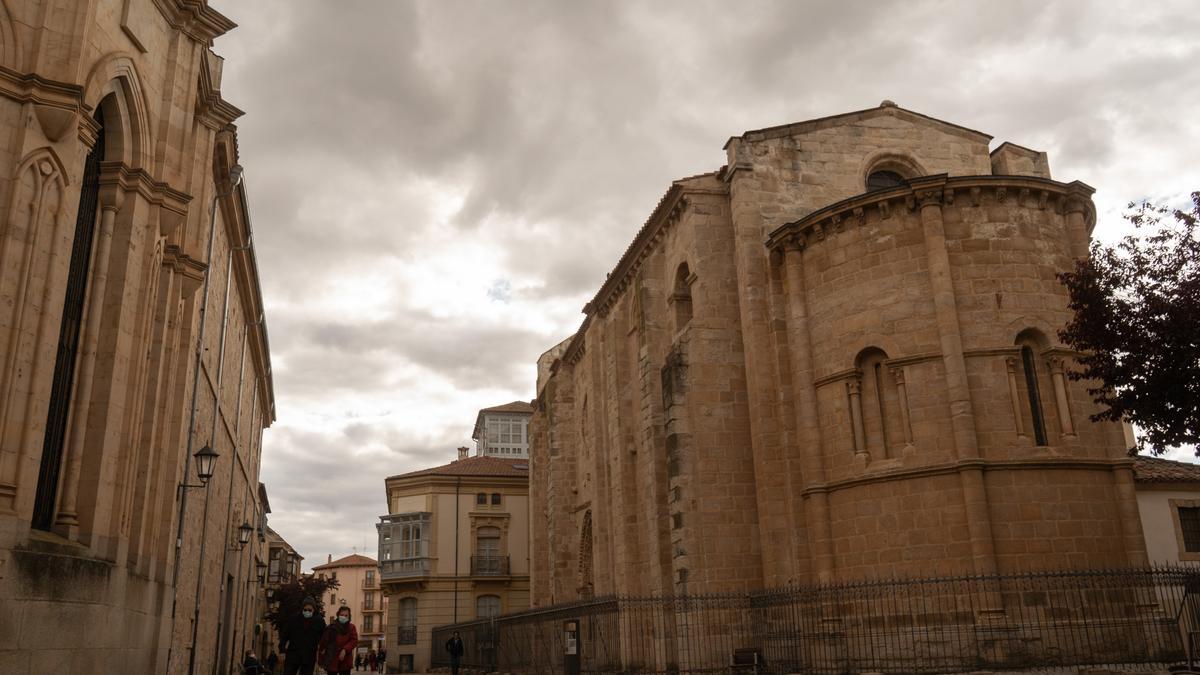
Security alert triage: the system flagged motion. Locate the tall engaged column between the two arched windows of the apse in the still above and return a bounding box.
[912,181,996,574]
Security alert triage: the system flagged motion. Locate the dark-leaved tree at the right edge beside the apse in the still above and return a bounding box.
[1058,192,1200,454]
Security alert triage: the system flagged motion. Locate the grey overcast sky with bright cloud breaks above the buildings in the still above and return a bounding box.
[211,0,1200,568]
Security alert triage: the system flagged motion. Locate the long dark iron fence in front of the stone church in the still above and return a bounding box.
[432,567,1200,675]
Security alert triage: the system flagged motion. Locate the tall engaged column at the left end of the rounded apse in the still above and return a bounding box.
[784,237,833,584]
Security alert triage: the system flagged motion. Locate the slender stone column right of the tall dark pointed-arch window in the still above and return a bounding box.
[54,181,125,538]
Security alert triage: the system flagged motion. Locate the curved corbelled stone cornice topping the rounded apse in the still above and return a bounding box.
[766,174,1096,250]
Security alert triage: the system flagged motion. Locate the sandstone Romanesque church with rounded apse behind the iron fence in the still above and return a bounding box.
[530,101,1146,605]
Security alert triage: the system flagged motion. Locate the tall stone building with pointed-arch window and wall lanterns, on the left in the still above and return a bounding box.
[0,0,275,674]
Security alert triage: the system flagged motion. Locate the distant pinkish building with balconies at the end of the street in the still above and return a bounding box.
[312,554,388,655]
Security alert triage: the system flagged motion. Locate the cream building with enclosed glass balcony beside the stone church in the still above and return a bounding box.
[376,456,529,673]
